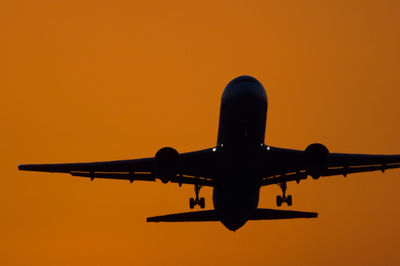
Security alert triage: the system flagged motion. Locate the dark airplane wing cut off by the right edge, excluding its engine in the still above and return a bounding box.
[262,144,400,185]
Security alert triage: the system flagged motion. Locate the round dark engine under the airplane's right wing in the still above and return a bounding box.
[305,143,329,179]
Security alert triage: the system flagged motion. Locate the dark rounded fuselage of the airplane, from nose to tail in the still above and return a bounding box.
[213,76,268,231]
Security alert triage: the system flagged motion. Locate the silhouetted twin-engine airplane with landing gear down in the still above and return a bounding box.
[18,75,400,231]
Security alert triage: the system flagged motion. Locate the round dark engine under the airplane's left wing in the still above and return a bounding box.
[154,147,179,183]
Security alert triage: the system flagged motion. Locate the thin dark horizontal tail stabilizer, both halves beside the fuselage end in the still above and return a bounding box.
[147,209,318,222]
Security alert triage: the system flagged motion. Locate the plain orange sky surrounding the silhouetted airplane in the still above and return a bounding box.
[0,0,400,265]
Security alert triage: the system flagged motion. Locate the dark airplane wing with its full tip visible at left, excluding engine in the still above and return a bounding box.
[18,149,215,186]
